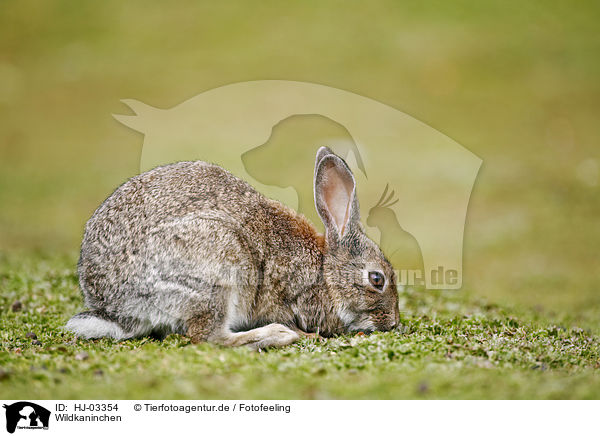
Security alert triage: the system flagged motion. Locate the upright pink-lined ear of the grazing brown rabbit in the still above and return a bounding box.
[314,152,360,245]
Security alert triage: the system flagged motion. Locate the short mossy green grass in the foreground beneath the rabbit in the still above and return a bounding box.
[0,256,600,399]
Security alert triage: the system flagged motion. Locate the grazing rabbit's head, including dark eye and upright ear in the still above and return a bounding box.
[314,147,399,332]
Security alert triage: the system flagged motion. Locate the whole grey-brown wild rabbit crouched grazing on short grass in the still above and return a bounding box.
[65,147,399,349]
